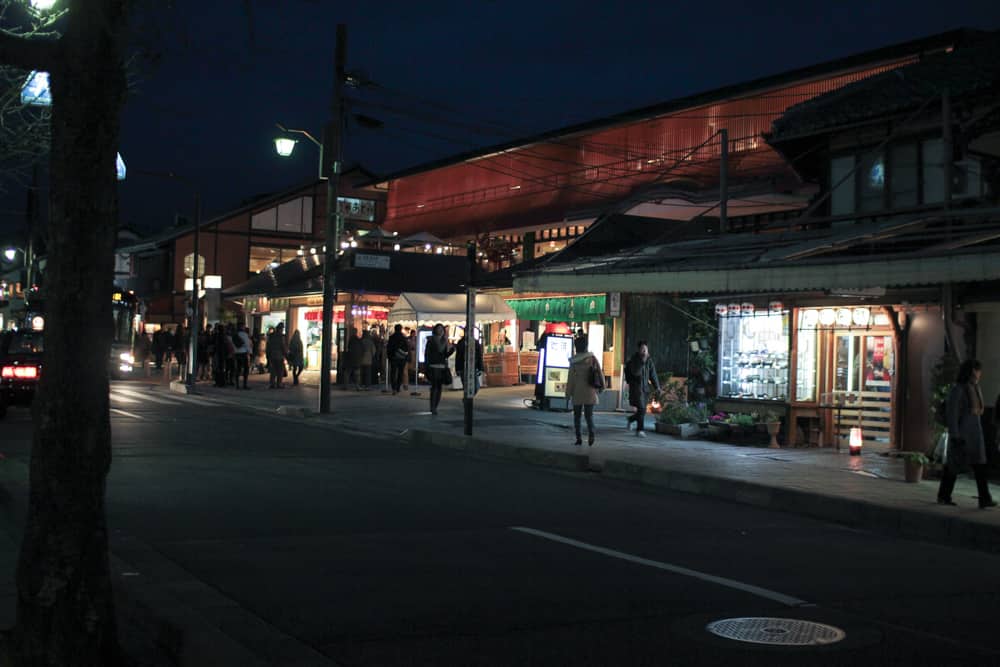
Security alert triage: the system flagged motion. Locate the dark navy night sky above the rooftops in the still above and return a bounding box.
[5,0,1000,237]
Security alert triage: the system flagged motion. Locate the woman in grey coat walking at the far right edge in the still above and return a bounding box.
[938,359,997,509]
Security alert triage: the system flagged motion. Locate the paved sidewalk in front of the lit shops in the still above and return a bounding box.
[172,373,1000,552]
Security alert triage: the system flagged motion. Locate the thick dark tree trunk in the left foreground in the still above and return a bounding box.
[13,0,126,667]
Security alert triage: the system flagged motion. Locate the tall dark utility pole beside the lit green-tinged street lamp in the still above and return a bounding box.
[319,23,347,414]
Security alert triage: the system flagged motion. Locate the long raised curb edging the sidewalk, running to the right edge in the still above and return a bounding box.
[403,429,1000,553]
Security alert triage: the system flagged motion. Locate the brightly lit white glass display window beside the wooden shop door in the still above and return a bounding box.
[718,311,789,401]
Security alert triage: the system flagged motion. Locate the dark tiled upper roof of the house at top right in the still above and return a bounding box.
[767,32,1000,144]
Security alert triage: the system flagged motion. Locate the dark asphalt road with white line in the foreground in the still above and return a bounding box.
[0,385,1000,667]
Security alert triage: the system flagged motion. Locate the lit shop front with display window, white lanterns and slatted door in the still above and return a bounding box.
[715,300,897,451]
